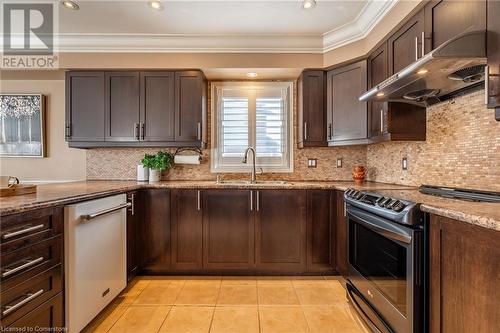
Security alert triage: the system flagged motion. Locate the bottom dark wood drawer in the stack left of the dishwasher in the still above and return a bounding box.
[9,293,64,332]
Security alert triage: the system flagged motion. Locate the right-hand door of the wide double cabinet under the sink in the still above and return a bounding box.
[255,190,306,272]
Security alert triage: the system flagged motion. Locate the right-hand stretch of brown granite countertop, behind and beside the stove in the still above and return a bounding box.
[377,189,500,231]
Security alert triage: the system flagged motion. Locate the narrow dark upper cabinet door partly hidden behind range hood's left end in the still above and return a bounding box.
[368,42,389,137]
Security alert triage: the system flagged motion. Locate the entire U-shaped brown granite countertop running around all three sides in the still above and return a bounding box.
[0,180,500,231]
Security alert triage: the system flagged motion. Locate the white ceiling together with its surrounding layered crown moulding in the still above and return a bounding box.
[55,0,398,53]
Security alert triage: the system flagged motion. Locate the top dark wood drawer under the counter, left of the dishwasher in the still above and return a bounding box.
[0,207,64,253]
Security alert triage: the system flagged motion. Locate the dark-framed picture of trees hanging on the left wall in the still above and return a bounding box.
[0,94,46,157]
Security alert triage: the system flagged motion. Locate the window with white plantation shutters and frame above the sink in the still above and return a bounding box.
[212,82,293,172]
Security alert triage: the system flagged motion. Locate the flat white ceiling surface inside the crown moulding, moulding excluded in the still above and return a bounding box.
[59,0,368,35]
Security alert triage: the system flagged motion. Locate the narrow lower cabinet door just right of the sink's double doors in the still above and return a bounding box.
[307,190,335,272]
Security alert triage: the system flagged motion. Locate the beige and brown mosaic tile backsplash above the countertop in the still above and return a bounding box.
[87,91,500,191]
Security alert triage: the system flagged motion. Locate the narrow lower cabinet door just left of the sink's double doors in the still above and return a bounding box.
[171,189,203,270]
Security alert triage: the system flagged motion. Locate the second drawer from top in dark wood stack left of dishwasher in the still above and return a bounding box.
[0,236,63,290]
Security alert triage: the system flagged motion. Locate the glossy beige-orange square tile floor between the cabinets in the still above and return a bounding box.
[84,276,367,333]
